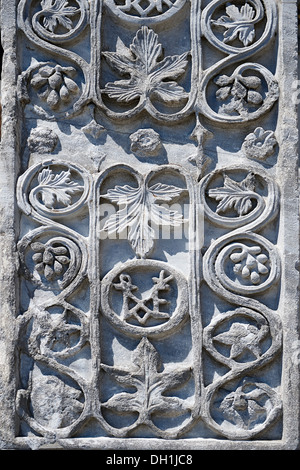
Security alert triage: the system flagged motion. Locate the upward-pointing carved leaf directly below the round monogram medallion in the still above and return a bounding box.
[102,338,191,421]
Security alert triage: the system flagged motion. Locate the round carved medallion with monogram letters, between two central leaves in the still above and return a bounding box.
[101,259,188,337]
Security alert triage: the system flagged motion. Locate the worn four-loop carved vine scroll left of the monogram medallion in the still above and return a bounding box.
[17,160,90,439]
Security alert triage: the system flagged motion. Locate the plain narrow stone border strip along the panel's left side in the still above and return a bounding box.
[0,0,19,449]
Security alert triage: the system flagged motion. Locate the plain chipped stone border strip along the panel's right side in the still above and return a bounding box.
[277,0,300,449]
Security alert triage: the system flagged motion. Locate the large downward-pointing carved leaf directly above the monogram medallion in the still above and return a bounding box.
[103,183,183,257]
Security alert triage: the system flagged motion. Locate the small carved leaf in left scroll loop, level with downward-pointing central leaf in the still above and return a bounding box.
[38,168,83,209]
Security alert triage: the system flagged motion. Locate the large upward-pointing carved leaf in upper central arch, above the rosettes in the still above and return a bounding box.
[103,26,188,104]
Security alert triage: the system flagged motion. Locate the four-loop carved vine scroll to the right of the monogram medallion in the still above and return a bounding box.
[202,167,282,439]
